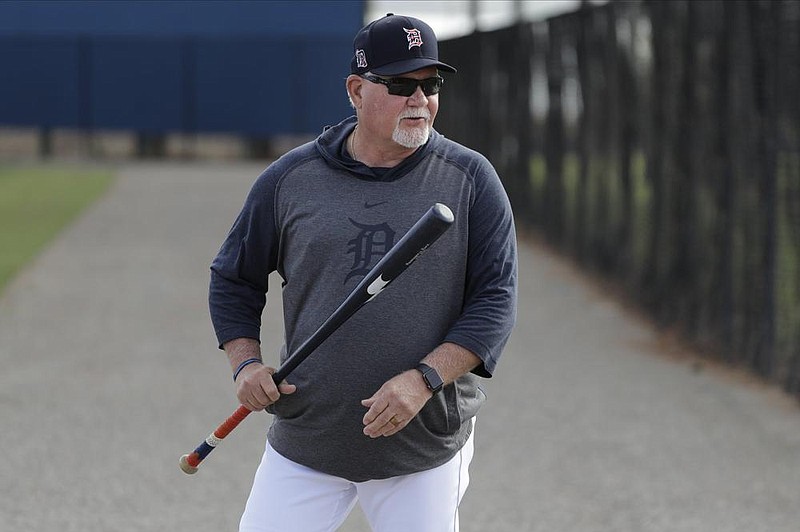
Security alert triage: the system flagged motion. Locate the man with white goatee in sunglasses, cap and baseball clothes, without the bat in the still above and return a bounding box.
[209,14,517,532]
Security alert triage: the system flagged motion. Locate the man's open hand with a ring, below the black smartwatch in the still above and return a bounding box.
[361,369,433,438]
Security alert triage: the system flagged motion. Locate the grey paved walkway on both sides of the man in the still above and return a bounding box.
[0,164,800,532]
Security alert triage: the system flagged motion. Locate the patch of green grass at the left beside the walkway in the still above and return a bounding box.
[0,166,113,294]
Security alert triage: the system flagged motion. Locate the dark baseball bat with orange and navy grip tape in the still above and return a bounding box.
[179,203,455,475]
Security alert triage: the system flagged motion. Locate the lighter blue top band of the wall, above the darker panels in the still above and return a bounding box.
[0,0,365,41]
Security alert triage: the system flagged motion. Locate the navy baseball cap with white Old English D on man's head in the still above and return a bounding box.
[350,13,456,76]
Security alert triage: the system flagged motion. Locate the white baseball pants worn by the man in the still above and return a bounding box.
[239,425,474,532]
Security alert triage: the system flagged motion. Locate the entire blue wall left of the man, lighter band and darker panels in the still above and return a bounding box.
[0,1,364,136]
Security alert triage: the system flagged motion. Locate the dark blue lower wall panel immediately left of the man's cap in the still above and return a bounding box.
[194,38,351,135]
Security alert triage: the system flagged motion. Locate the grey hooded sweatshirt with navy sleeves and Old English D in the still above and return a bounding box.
[209,117,517,482]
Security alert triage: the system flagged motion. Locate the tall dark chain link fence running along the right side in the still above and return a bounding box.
[437,0,800,396]
